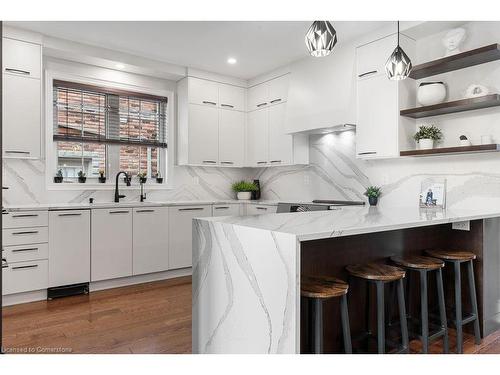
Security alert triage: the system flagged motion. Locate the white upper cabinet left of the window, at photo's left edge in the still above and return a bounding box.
[2,38,42,159]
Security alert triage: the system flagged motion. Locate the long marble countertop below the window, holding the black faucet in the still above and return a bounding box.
[4,199,278,212]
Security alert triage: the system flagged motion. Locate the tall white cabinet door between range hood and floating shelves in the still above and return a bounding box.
[356,75,399,158]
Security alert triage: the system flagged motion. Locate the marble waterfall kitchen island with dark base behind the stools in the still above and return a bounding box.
[192,207,500,353]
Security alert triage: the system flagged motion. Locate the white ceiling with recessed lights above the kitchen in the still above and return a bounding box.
[6,21,387,79]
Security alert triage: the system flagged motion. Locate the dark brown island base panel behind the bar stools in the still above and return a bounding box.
[300,219,500,353]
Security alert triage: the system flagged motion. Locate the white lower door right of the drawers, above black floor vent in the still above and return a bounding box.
[49,210,90,287]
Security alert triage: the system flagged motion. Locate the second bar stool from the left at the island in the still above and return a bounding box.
[346,263,409,354]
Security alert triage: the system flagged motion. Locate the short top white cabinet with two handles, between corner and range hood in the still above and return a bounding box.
[247,74,290,111]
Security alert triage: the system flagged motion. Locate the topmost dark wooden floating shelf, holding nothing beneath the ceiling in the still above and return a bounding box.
[410,43,500,79]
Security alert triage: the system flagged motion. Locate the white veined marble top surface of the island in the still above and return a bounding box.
[197,206,500,241]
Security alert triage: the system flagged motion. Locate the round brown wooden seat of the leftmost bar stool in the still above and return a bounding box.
[300,276,349,299]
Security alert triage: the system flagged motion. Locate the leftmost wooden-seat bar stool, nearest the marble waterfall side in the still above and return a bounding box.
[300,276,352,354]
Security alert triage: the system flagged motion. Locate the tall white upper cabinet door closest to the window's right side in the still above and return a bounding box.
[188,104,219,165]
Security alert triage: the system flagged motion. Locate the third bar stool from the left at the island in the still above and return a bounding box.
[391,255,449,353]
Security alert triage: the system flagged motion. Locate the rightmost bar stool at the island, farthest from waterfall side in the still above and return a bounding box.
[426,250,481,353]
